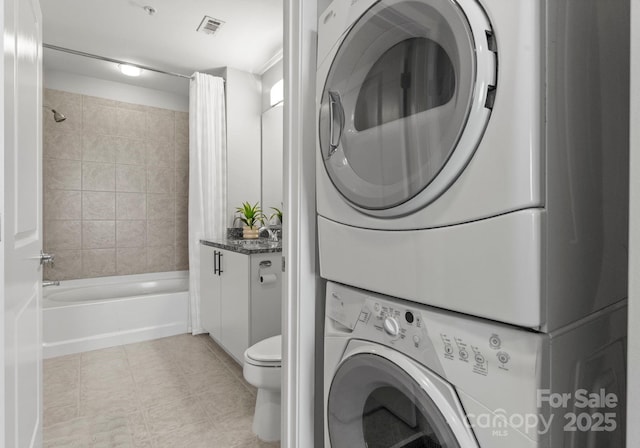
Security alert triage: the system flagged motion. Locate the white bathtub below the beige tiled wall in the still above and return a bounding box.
[42,271,189,358]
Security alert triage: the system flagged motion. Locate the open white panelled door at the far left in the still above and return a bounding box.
[0,0,42,448]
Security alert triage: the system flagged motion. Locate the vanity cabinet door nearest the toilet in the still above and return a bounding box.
[220,250,249,364]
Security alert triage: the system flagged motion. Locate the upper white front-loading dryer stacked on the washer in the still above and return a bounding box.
[316,0,629,331]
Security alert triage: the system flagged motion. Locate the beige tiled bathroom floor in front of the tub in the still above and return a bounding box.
[44,335,279,448]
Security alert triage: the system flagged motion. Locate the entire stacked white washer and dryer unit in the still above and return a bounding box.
[316,0,629,448]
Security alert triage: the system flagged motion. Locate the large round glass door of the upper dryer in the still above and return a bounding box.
[319,0,496,217]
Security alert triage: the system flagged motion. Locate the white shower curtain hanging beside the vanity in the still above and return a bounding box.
[189,72,227,334]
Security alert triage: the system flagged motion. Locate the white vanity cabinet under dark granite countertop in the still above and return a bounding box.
[200,245,282,364]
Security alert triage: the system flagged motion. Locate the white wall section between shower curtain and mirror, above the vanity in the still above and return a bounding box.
[226,68,262,226]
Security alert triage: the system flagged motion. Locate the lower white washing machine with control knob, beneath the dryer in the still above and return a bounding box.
[324,282,626,448]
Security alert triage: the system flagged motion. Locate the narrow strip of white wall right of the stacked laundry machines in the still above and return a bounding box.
[627,0,640,447]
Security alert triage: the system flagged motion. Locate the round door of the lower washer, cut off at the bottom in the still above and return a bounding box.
[327,349,477,448]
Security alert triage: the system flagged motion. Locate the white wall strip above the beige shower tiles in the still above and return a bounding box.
[43,68,189,113]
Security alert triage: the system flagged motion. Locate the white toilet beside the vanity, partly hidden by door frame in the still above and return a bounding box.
[243,335,282,442]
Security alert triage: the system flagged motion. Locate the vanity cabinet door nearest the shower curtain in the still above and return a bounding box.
[200,245,220,340]
